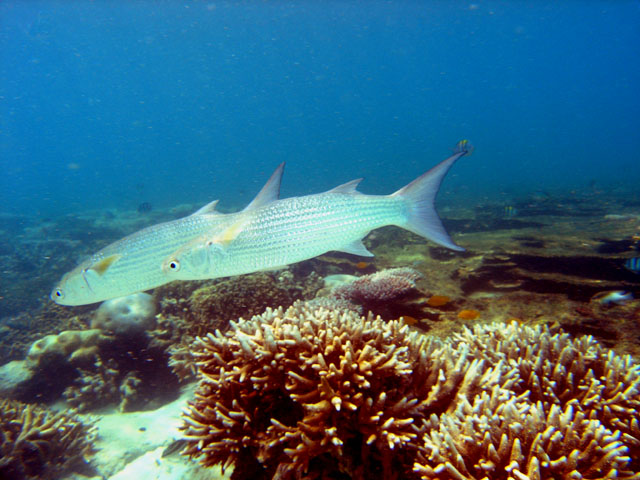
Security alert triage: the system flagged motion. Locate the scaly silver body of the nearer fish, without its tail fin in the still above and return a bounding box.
[163,192,407,280]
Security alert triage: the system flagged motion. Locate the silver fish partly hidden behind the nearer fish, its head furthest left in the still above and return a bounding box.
[51,165,280,306]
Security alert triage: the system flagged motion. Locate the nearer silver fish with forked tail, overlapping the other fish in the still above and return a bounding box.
[162,140,471,280]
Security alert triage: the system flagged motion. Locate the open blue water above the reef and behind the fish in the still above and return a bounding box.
[0,0,640,215]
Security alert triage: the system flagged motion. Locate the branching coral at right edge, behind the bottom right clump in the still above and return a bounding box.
[455,322,640,470]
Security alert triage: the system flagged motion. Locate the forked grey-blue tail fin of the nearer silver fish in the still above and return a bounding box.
[393,140,473,251]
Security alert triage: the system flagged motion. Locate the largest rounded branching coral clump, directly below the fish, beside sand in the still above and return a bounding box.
[183,303,514,479]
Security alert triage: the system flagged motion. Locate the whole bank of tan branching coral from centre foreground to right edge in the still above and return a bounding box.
[178,303,640,480]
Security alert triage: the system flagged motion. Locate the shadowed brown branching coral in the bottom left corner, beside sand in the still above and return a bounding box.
[0,400,94,480]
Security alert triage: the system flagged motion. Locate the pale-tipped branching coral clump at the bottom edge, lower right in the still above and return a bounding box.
[414,387,640,480]
